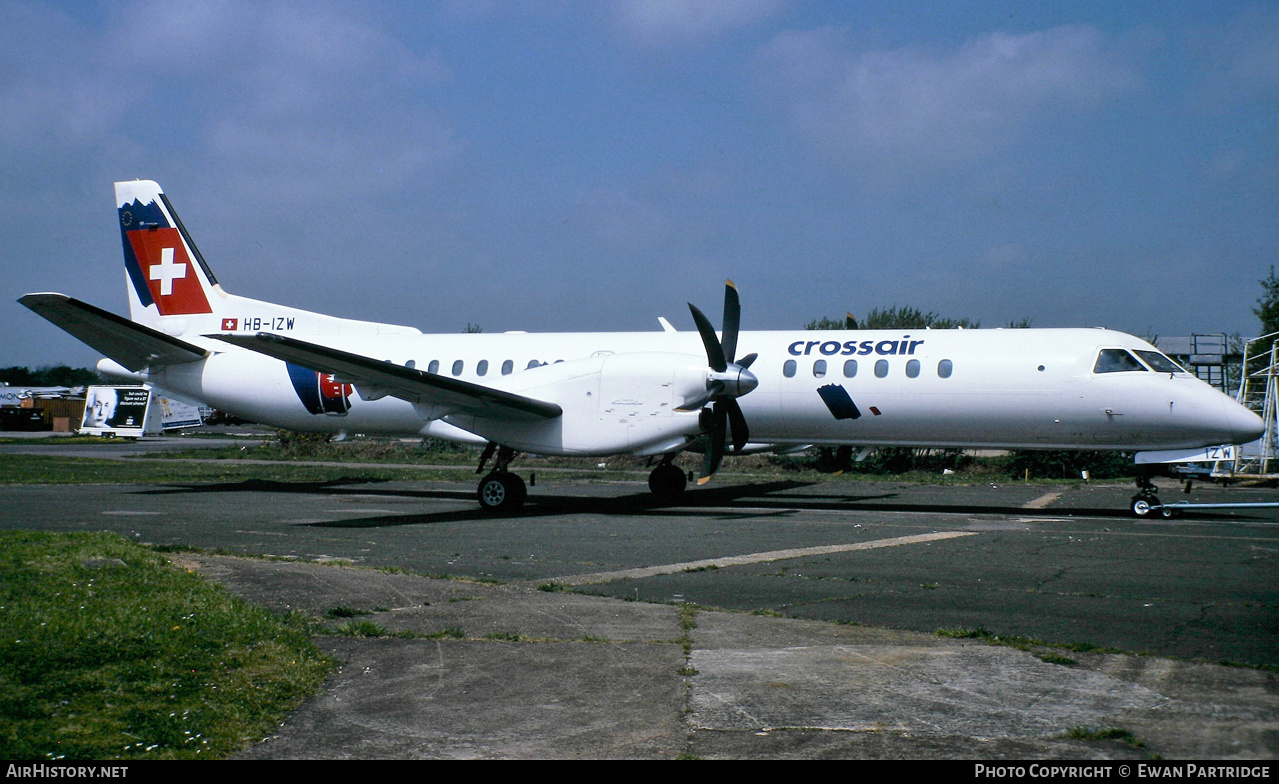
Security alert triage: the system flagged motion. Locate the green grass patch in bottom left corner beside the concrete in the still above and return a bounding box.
[0,531,331,760]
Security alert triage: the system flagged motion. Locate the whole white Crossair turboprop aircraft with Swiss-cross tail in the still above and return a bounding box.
[20,180,1264,513]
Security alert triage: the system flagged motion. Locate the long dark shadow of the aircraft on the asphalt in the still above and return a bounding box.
[129,478,1171,528]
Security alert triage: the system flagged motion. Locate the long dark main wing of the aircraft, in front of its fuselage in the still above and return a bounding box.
[207,333,564,421]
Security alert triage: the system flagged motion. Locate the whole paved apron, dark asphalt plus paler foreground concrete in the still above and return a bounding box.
[0,437,1279,760]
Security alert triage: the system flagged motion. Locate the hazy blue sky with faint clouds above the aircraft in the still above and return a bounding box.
[0,0,1279,367]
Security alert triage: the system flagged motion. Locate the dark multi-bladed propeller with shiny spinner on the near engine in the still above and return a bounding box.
[680,280,760,485]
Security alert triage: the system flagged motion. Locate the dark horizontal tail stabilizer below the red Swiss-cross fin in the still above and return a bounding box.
[18,293,208,372]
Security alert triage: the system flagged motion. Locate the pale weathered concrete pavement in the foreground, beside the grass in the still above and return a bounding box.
[175,555,1279,760]
